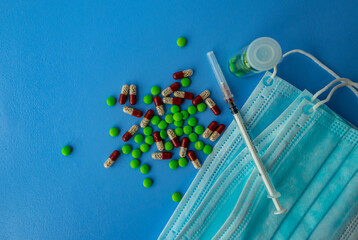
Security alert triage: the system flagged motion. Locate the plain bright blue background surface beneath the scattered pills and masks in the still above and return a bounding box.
[0,0,358,239]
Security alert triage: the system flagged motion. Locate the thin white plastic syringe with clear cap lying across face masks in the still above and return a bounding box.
[207,51,287,214]
